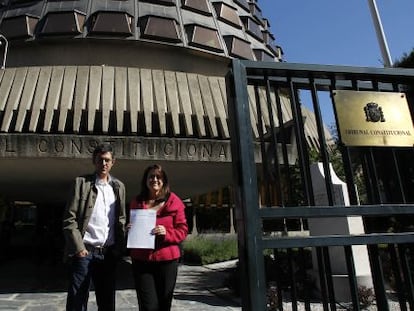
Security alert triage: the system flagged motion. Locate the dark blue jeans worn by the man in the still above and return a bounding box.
[66,250,117,311]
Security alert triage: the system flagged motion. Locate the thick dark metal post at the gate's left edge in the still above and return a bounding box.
[226,60,266,311]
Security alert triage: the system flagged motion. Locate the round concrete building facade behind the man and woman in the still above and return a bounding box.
[0,0,328,254]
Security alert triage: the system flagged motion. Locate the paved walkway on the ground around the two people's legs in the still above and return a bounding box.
[0,261,241,311]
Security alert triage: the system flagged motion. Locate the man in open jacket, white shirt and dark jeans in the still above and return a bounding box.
[63,145,126,311]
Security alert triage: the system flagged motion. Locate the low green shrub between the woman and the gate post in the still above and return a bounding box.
[183,234,238,265]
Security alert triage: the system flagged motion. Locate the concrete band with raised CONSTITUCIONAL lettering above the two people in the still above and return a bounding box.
[0,135,231,162]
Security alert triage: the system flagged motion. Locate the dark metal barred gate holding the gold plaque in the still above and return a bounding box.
[227,60,414,310]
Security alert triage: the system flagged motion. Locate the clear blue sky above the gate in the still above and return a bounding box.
[257,0,414,127]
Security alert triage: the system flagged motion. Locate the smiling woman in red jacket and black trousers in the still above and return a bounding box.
[130,165,188,311]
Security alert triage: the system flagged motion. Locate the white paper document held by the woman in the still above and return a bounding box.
[127,209,157,249]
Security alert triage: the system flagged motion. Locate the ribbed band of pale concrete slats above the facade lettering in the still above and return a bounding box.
[0,66,233,139]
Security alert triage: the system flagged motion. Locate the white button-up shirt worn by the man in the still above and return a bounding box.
[83,178,116,247]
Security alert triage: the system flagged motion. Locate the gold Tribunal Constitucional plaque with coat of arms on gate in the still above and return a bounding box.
[333,90,414,147]
